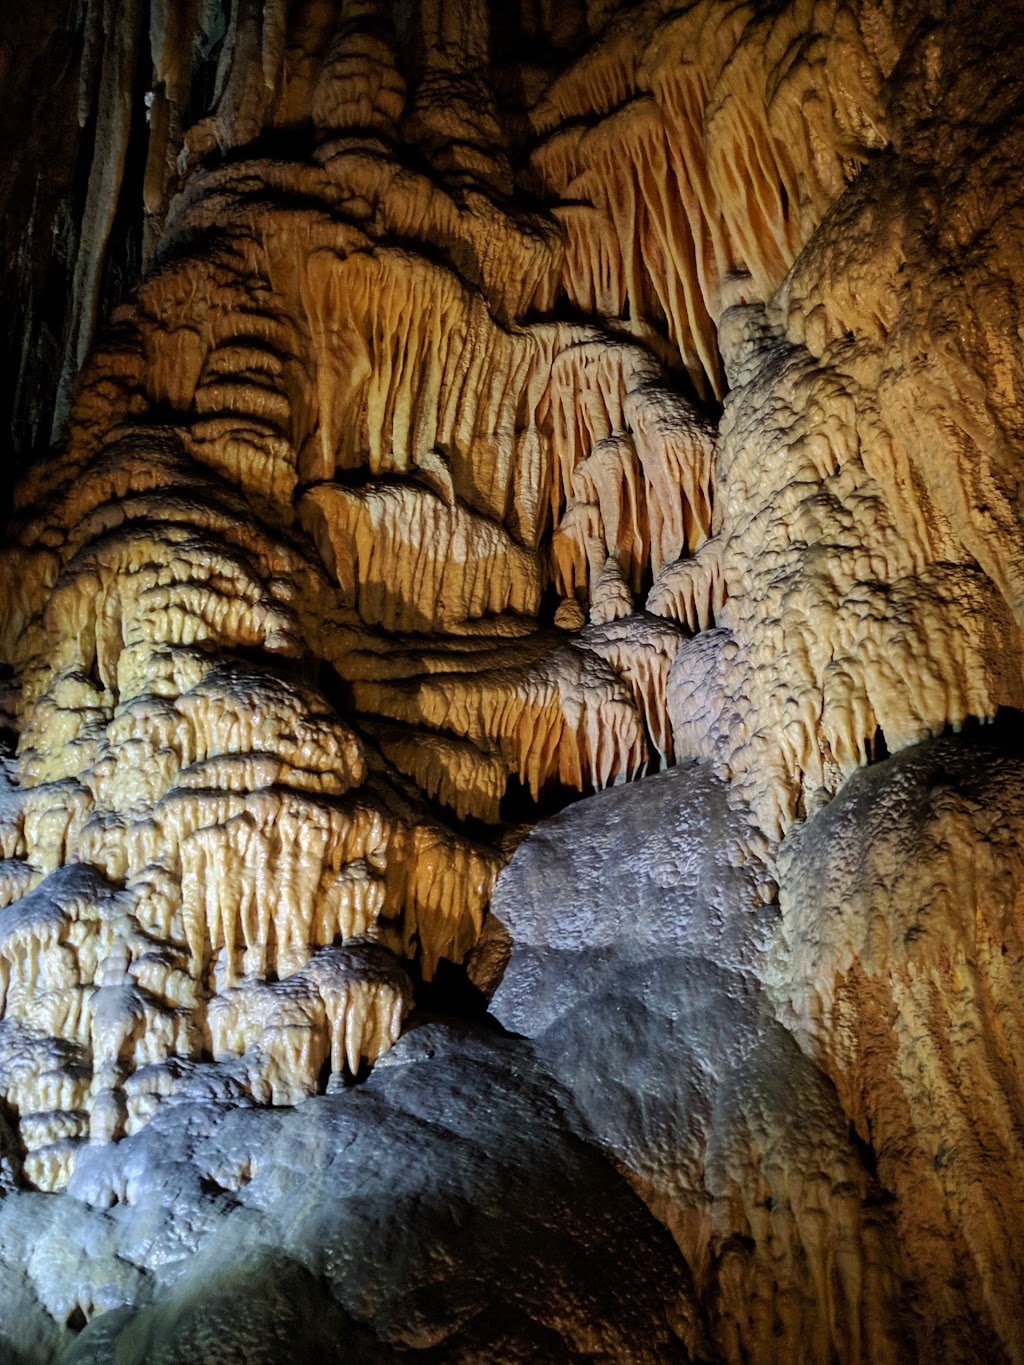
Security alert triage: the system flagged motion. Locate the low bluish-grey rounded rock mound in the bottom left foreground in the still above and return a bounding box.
[0,1024,689,1365]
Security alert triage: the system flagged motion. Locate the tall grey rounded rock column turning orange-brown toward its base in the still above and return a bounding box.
[492,763,907,1360]
